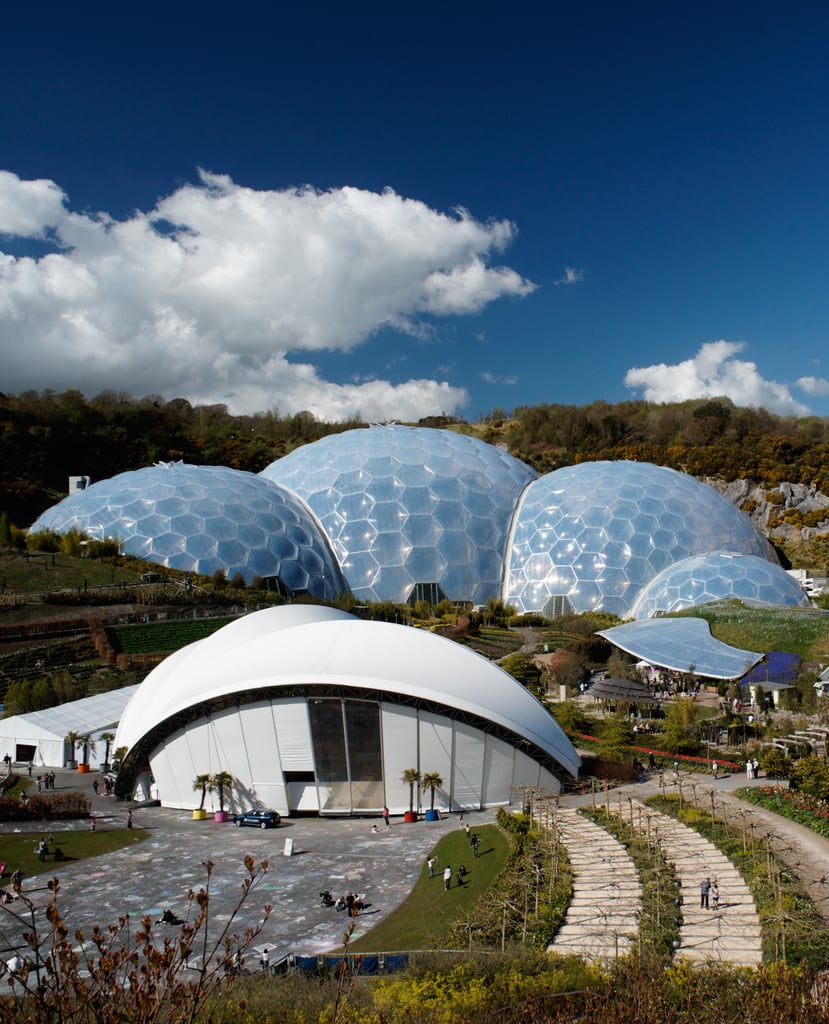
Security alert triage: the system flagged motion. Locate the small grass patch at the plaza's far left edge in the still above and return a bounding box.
[0,821,149,887]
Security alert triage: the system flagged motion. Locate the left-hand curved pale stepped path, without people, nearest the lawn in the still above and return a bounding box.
[548,809,642,961]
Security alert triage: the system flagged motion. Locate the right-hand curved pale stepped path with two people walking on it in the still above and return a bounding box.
[645,808,762,967]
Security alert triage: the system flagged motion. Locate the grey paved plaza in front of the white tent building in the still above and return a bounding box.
[0,770,494,963]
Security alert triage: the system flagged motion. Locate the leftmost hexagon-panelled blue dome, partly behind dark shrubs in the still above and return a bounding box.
[30,462,347,600]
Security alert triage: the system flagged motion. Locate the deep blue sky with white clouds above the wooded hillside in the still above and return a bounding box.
[0,0,829,420]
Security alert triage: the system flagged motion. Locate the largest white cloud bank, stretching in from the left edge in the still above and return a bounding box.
[0,171,534,419]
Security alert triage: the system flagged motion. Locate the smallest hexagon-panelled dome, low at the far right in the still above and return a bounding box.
[630,551,809,618]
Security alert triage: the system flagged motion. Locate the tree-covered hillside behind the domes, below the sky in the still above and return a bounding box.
[0,391,829,566]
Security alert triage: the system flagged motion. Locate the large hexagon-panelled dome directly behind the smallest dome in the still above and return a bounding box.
[505,462,777,618]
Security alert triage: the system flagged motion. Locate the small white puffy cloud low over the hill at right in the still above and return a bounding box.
[624,341,810,416]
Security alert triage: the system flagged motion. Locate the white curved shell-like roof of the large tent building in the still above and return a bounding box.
[116,605,579,775]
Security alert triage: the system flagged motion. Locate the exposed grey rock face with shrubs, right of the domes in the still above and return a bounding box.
[703,477,829,541]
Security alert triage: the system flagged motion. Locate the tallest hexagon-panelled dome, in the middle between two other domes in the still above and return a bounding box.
[262,426,537,603]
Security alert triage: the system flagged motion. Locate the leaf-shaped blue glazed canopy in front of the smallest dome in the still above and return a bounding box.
[598,615,763,679]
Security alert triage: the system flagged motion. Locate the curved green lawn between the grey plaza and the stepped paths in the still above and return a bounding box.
[343,825,510,952]
